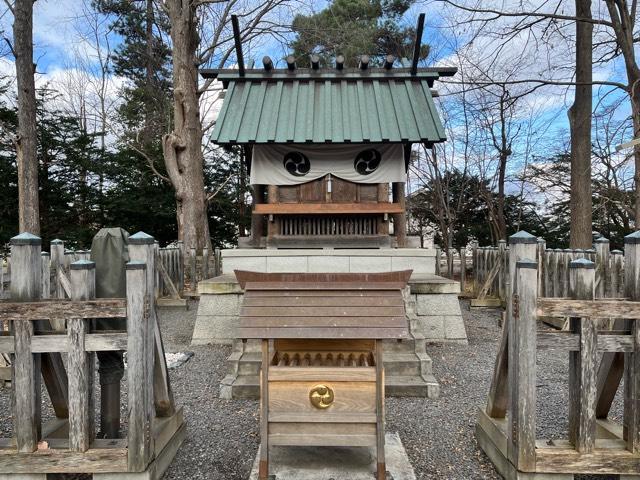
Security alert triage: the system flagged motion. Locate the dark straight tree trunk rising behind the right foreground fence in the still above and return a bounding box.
[569,0,593,248]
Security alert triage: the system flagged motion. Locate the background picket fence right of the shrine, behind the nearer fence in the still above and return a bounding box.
[472,237,624,303]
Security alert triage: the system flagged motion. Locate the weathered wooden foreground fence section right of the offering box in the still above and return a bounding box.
[476,232,640,480]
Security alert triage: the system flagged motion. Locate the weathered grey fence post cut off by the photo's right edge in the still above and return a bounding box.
[624,231,640,453]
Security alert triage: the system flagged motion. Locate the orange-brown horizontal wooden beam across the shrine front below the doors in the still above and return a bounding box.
[253,203,404,215]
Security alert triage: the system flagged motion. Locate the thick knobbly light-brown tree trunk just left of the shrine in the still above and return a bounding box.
[162,0,211,252]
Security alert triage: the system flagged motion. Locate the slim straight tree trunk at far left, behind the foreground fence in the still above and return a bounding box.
[13,0,40,235]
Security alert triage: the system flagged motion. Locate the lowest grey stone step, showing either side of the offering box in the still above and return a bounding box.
[224,375,440,399]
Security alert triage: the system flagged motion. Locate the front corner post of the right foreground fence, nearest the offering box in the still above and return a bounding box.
[508,256,538,471]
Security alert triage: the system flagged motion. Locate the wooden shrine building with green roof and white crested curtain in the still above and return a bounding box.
[201,17,456,248]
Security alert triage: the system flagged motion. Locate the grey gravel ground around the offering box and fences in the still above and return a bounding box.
[0,302,621,480]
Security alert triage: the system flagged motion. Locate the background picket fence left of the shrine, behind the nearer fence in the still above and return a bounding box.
[0,239,222,300]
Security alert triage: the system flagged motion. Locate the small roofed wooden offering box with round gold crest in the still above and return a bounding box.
[235,270,411,480]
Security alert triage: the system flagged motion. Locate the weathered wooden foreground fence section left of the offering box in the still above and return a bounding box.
[0,234,185,479]
